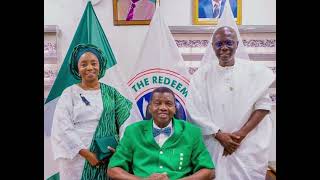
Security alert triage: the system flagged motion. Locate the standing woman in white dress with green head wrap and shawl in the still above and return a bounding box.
[51,44,132,180]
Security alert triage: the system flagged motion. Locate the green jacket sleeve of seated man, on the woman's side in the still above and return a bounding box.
[108,126,133,172]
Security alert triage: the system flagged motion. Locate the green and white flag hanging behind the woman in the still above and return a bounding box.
[44,1,117,179]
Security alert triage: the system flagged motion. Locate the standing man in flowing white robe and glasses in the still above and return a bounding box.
[186,26,275,180]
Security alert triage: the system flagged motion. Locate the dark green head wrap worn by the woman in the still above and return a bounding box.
[69,44,107,80]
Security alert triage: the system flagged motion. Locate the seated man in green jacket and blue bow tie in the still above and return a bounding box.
[108,87,214,180]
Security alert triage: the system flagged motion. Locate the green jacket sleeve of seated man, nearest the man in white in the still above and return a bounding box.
[191,128,215,173]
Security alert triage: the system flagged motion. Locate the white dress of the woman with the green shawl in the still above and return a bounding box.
[51,85,103,180]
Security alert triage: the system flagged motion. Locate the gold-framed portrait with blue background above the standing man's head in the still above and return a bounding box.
[192,0,242,25]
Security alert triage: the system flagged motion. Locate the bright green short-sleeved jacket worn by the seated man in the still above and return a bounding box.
[108,119,214,179]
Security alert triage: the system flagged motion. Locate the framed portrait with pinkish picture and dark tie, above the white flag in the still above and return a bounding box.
[113,0,160,26]
